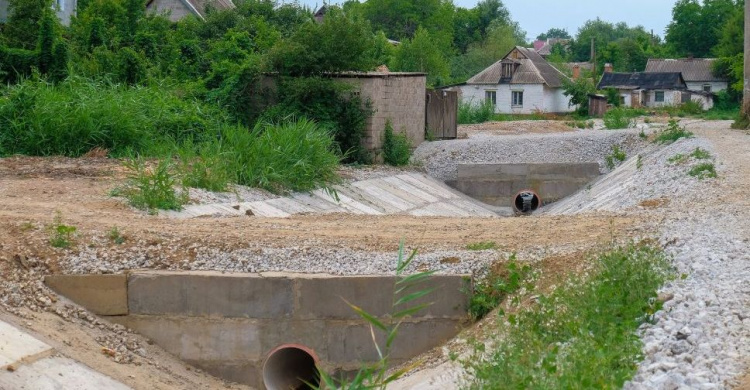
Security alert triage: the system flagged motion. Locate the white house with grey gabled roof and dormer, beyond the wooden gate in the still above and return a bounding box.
[443,46,575,114]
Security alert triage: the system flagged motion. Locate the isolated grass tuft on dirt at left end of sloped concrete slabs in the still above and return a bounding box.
[111,156,188,214]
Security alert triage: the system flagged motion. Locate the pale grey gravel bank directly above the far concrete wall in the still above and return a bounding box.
[412,129,648,181]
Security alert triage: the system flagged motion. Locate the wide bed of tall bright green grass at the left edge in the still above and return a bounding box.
[0,78,232,157]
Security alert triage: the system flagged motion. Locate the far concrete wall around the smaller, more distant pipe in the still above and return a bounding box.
[447,163,599,207]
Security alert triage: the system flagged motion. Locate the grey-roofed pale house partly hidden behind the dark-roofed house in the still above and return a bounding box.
[646,58,729,93]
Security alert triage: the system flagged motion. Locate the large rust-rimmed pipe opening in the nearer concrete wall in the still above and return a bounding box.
[263,344,320,390]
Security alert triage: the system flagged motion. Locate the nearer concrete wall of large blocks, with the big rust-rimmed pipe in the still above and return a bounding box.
[45,271,471,389]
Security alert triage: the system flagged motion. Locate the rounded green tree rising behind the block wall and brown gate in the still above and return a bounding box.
[393,27,450,85]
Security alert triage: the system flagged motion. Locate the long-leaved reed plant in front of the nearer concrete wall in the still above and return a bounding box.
[310,241,435,390]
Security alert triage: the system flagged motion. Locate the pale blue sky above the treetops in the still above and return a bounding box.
[287,0,676,39]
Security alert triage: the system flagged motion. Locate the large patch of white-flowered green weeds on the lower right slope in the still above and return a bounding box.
[466,244,671,390]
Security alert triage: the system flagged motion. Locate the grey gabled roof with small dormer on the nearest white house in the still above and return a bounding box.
[466,46,566,88]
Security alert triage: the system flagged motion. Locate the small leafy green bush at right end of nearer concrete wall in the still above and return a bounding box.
[469,254,534,320]
